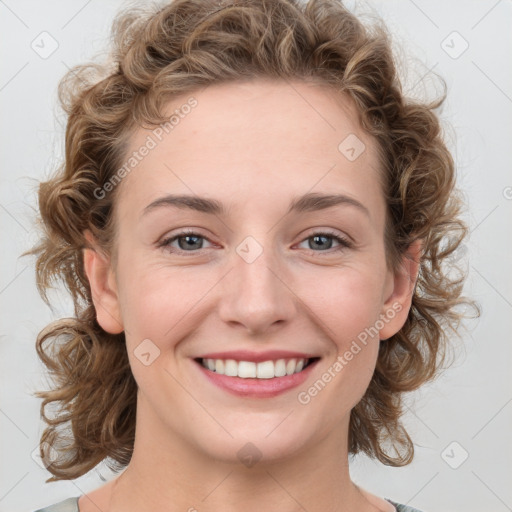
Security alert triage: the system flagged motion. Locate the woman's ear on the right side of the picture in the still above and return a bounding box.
[379,239,423,340]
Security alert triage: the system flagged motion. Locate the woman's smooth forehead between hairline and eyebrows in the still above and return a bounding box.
[113,80,381,222]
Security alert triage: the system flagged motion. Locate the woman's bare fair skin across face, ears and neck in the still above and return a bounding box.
[79,80,421,512]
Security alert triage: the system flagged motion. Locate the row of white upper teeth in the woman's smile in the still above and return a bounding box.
[201,359,308,379]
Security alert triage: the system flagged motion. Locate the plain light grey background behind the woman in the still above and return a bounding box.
[0,0,512,512]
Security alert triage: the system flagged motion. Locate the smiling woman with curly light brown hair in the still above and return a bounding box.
[28,0,473,512]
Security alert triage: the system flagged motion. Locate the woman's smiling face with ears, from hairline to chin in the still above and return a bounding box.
[86,80,418,461]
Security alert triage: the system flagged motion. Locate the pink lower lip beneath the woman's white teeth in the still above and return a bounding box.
[194,359,319,398]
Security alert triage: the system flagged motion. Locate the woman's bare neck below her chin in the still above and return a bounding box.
[108,396,389,512]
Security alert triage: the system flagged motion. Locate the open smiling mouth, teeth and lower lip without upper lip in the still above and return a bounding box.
[194,357,320,399]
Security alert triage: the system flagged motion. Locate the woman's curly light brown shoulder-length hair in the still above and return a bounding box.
[25,0,479,482]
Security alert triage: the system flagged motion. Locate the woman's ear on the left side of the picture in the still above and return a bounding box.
[83,230,123,334]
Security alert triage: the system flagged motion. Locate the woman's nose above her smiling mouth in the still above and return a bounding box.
[219,241,297,335]
